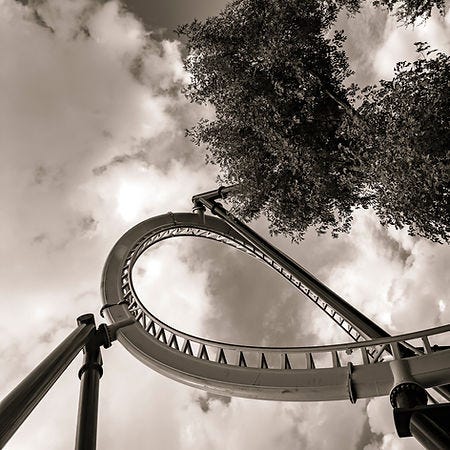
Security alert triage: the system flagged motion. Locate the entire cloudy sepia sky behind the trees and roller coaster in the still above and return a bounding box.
[0,0,450,450]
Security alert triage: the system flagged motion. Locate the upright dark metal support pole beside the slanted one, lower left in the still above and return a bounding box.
[75,314,103,450]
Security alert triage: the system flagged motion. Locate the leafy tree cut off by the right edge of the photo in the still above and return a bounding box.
[355,43,450,242]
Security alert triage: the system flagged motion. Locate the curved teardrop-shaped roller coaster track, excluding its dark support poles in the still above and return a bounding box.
[102,211,450,402]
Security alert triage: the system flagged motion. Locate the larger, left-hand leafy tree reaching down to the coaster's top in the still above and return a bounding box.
[178,0,372,238]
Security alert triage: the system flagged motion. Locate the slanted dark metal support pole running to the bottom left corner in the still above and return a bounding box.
[0,316,95,448]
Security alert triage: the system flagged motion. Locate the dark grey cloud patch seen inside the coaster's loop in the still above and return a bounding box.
[181,239,340,346]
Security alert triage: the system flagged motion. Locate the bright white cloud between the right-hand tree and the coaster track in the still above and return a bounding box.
[328,208,450,334]
